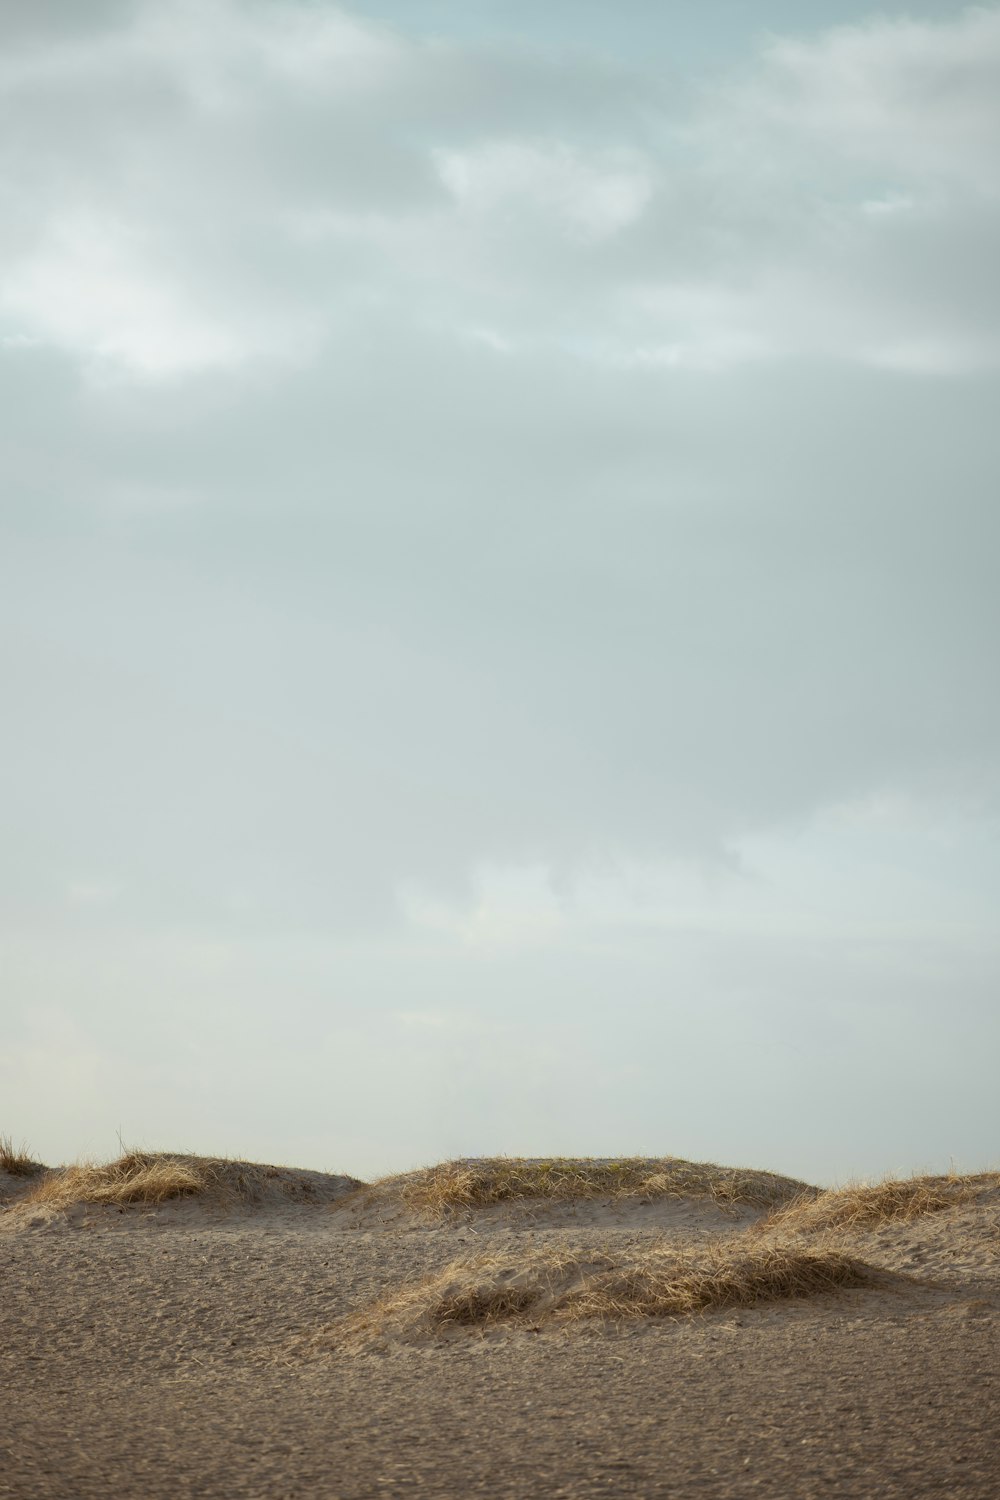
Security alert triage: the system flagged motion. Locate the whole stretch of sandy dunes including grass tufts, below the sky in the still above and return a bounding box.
[0,1152,1000,1500]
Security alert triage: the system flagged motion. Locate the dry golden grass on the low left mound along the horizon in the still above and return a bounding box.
[21,1151,316,1209]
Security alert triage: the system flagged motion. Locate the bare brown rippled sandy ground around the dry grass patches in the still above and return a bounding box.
[0,1179,1000,1500]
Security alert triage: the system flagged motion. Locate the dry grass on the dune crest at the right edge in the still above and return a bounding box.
[757,1172,1000,1230]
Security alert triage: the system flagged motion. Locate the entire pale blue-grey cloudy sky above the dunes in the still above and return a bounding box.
[0,0,1000,1184]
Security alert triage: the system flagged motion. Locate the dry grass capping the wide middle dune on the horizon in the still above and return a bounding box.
[370,1157,816,1218]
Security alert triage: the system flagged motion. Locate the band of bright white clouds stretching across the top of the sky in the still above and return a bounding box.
[0,0,1000,377]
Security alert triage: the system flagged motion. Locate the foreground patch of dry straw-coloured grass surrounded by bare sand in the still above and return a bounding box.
[335,1236,879,1349]
